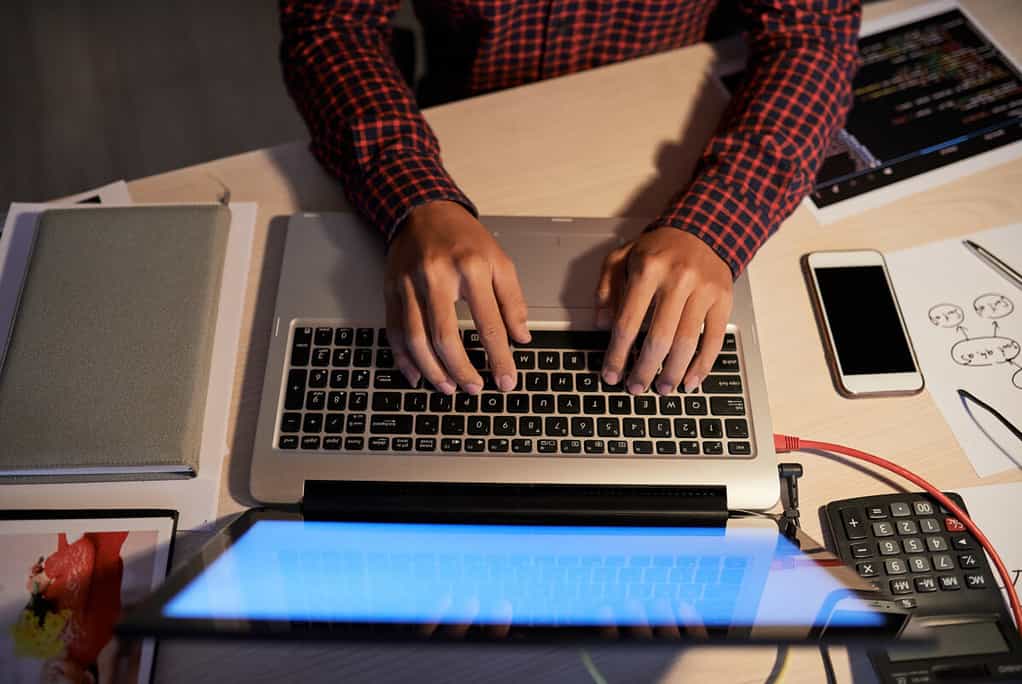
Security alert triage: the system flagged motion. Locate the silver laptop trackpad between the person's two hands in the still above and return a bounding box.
[496,231,623,309]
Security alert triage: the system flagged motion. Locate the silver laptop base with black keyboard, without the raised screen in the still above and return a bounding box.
[251,214,779,510]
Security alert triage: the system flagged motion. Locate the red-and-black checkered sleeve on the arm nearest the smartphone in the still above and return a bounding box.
[650,0,862,277]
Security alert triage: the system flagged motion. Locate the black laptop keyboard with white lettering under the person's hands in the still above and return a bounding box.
[276,322,755,459]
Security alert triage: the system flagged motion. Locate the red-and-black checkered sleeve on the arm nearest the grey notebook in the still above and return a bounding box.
[280,0,476,239]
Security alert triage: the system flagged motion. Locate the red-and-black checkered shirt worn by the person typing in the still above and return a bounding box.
[280,0,861,276]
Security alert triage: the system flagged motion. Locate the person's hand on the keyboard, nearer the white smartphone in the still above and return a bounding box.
[596,227,733,395]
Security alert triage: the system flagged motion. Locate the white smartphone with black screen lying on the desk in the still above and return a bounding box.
[802,249,923,397]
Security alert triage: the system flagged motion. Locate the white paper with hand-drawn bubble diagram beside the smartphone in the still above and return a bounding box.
[887,224,1022,477]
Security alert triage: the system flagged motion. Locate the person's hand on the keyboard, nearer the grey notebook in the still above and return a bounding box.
[384,201,530,395]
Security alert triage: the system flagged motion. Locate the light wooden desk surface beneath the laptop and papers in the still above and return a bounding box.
[130,0,1022,682]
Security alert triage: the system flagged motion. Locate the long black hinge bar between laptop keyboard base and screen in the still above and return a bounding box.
[301,480,728,527]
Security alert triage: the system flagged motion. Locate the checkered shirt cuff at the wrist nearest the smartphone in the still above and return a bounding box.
[646,177,771,278]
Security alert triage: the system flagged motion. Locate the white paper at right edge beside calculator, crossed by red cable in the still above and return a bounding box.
[956,483,1022,617]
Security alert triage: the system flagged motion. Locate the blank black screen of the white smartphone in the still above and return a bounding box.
[815,266,916,375]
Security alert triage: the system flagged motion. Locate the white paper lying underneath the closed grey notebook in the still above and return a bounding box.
[0,202,257,530]
